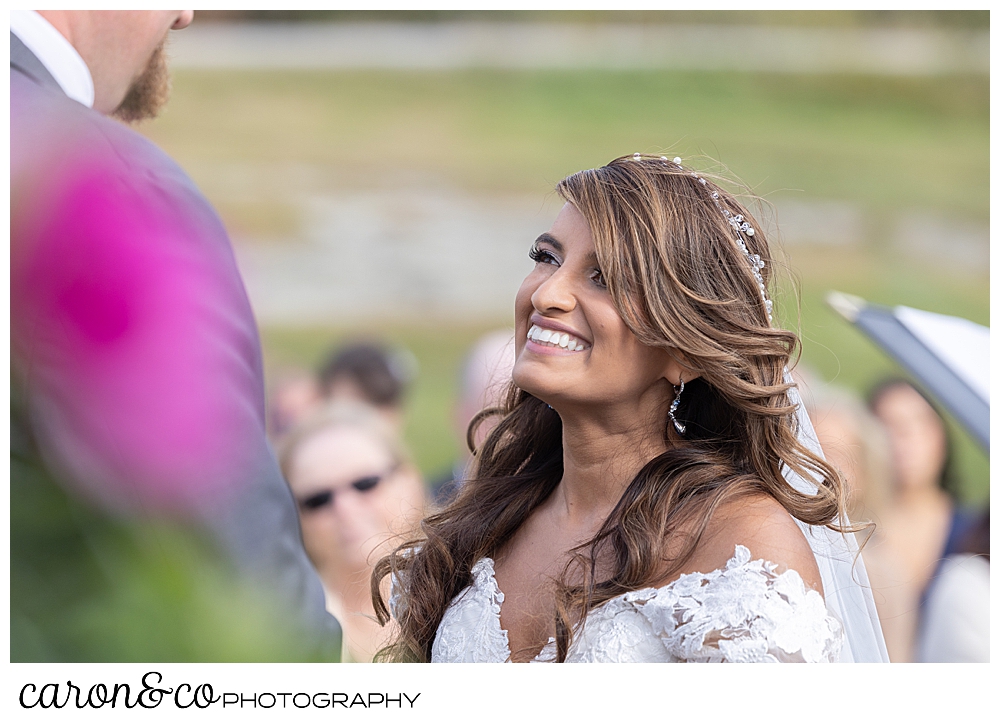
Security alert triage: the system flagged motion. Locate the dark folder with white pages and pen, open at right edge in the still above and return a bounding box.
[826,291,990,453]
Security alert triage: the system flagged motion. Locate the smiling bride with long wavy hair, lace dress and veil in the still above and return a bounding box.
[372,154,885,662]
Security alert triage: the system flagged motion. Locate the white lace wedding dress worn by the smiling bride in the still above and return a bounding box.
[431,545,844,663]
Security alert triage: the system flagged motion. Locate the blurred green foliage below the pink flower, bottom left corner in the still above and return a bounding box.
[10,387,339,663]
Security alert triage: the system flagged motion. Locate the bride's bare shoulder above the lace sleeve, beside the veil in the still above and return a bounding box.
[683,493,823,593]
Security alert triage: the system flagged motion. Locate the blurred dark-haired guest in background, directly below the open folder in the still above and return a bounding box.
[868,378,975,660]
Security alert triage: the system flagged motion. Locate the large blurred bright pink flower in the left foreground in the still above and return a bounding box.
[11,155,263,511]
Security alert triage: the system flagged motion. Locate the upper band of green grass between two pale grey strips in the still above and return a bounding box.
[147,71,989,220]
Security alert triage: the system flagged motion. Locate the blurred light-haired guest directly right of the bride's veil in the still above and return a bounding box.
[803,382,920,662]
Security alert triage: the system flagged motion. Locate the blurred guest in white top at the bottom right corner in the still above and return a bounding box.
[917,508,990,663]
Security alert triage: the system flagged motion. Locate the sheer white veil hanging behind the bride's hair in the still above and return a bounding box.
[784,370,889,663]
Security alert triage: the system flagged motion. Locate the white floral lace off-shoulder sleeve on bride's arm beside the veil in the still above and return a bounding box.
[624,545,844,663]
